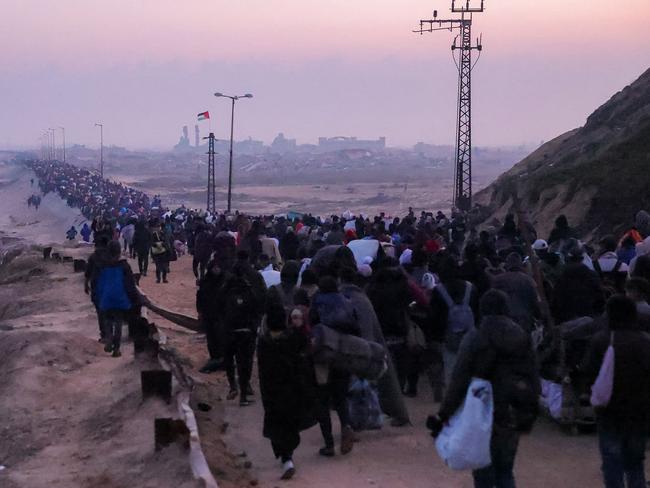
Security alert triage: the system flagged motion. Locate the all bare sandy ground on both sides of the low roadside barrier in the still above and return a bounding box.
[0,164,644,488]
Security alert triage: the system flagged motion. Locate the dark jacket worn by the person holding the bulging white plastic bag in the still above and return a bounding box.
[439,315,541,427]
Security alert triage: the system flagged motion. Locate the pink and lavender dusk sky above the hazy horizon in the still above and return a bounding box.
[0,0,650,149]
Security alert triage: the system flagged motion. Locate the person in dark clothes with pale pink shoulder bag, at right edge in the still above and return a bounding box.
[580,295,650,488]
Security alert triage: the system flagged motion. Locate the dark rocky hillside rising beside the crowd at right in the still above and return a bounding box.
[475,69,650,239]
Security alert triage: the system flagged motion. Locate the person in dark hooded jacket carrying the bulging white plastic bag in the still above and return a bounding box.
[427,290,541,488]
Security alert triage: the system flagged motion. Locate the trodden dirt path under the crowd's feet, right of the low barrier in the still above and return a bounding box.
[135,256,632,488]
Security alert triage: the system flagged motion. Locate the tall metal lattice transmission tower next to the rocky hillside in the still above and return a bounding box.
[413,0,484,211]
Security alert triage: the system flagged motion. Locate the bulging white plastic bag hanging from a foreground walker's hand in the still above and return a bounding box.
[436,378,494,470]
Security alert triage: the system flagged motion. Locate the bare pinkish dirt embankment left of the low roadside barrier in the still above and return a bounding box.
[0,241,198,488]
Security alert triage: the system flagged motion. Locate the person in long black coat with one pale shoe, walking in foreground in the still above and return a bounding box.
[257,303,316,479]
